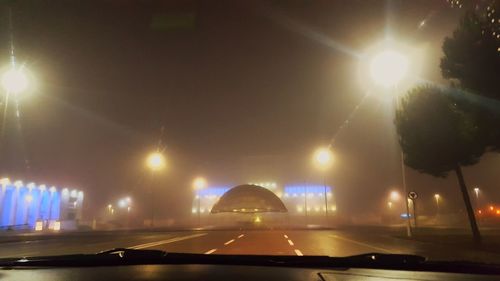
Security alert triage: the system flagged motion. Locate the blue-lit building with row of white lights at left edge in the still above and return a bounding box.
[0,179,83,231]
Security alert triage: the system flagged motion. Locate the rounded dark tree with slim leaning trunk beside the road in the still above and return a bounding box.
[394,86,486,242]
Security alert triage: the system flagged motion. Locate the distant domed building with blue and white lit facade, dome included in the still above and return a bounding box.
[191,181,337,226]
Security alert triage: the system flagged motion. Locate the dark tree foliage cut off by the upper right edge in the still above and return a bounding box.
[441,6,500,151]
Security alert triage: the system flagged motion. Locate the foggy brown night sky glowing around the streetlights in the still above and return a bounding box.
[0,0,500,217]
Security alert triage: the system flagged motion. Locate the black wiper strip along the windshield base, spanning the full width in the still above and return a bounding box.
[0,248,500,274]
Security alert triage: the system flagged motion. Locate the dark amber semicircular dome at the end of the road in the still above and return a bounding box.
[211,184,288,214]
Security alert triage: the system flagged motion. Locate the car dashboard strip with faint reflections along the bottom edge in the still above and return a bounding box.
[0,264,500,281]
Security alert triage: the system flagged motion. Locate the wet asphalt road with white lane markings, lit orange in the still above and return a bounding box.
[0,230,500,263]
